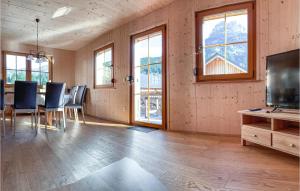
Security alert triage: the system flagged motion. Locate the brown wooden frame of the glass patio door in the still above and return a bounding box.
[130,24,167,130]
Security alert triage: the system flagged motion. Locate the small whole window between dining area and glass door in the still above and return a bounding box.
[94,44,114,88]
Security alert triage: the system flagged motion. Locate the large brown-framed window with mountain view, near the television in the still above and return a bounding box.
[196,2,255,81]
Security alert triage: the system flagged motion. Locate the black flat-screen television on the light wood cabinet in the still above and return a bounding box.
[266,49,300,109]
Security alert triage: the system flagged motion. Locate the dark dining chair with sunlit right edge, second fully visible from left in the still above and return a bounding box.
[38,82,66,132]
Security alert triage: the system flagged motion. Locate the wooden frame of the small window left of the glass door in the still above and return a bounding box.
[94,43,115,89]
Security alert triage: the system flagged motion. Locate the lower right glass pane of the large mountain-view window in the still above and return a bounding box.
[226,43,248,74]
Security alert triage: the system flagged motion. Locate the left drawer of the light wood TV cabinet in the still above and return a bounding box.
[242,125,271,146]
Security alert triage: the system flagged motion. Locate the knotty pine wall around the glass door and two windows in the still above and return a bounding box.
[75,0,300,134]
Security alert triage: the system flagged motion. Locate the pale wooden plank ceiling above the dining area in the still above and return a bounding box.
[1,0,173,50]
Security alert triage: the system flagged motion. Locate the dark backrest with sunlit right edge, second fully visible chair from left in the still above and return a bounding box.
[45,82,66,108]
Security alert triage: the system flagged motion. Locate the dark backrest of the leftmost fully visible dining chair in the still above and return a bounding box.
[14,81,37,109]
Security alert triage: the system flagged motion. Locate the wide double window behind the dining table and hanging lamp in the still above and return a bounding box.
[3,52,52,85]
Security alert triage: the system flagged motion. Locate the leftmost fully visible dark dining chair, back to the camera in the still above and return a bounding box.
[12,81,37,135]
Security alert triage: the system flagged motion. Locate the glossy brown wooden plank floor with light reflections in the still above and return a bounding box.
[1,117,299,191]
